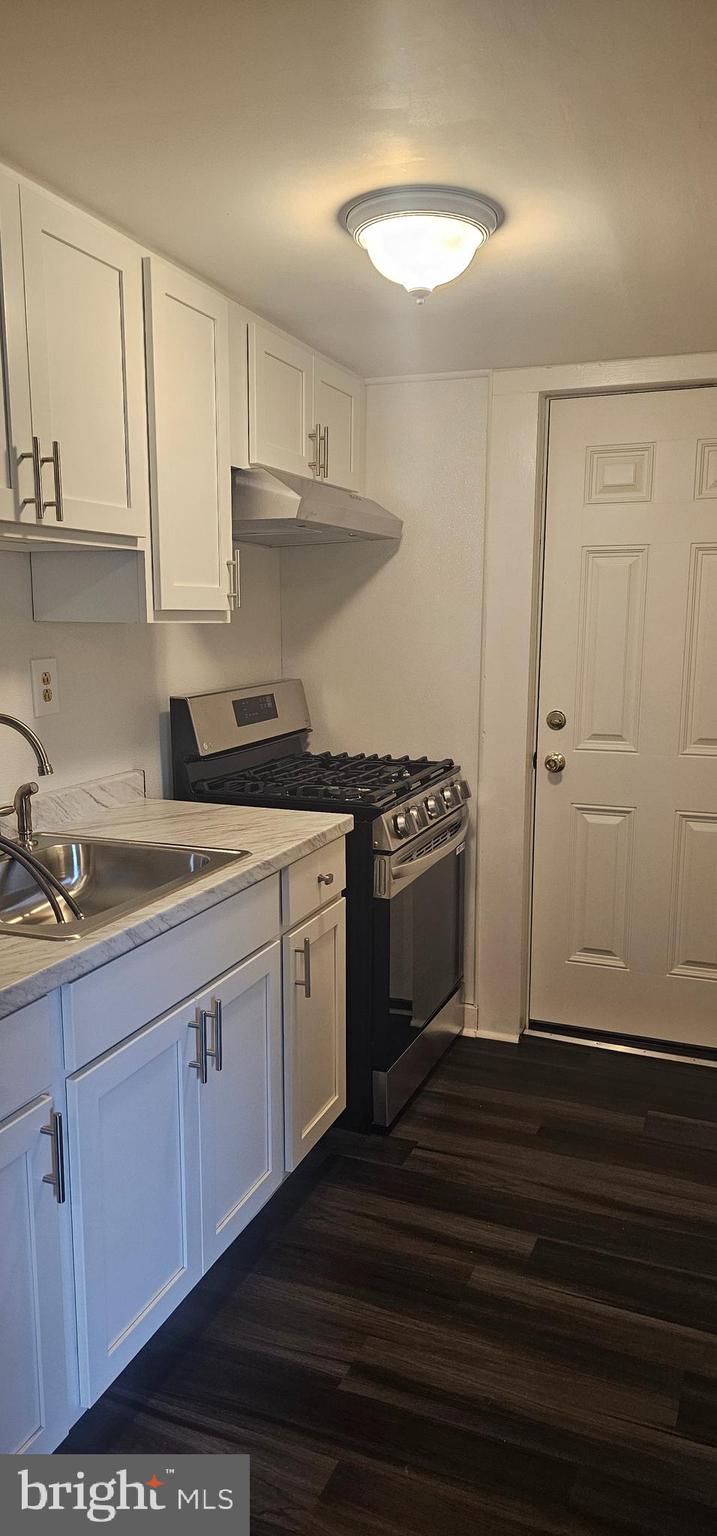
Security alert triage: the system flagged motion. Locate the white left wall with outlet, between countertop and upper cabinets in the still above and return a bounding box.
[0,548,281,800]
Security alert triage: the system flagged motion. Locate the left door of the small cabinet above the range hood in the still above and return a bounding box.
[249,319,315,475]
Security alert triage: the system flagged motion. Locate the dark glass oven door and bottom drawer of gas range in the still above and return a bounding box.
[373,806,468,1124]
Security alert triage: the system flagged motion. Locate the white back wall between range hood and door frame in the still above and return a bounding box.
[281,376,488,1001]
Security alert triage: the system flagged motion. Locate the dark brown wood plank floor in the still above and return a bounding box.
[61,1038,717,1536]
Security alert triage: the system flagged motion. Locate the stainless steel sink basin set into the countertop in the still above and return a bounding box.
[0,833,249,940]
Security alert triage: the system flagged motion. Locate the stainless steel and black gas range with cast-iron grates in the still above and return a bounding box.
[170,679,470,1129]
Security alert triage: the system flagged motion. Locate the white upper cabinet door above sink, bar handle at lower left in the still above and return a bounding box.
[20,186,149,538]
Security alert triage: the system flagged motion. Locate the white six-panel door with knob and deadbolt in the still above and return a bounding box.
[531,389,717,1046]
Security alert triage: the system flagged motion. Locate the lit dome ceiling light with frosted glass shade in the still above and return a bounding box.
[339,186,504,304]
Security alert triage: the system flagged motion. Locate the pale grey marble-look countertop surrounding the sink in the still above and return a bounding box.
[0,799,353,1018]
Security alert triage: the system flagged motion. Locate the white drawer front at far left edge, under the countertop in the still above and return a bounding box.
[0,992,61,1120]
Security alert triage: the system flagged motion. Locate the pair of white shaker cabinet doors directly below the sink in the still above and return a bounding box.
[68,940,284,1405]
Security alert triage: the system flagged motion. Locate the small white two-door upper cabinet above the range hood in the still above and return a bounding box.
[247,319,365,490]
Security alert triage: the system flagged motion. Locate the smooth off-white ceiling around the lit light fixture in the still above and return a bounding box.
[0,0,717,375]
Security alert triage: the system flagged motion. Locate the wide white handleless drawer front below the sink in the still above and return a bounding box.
[63,874,279,1072]
